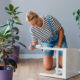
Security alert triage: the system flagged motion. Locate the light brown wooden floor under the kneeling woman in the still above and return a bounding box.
[13,59,80,80]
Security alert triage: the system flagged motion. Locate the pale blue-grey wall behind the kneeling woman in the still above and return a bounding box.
[11,0,80,53]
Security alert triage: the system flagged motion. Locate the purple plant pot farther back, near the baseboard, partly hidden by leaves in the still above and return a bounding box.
[9,46,20,62]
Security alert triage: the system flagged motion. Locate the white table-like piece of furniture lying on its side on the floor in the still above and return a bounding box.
[36,45,80,79]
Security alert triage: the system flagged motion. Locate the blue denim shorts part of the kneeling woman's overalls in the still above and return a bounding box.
[41,36,67,56]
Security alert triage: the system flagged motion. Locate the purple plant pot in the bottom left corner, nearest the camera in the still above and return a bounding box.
[0,66,13,80]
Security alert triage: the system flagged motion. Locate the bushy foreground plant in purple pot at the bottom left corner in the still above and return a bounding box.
[0,25,17,80]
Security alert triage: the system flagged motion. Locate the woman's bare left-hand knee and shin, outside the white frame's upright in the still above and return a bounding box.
[43,55,53,70]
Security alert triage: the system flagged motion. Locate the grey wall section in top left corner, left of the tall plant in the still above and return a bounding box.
[0,0,10,25]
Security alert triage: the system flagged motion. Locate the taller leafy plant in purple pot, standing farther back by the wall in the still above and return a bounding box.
[1,4,26,62]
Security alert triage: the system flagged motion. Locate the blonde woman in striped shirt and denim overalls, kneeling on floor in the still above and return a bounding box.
[26,11,67,70]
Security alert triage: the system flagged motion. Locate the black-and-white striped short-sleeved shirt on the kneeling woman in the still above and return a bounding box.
[30,16,62,42]
